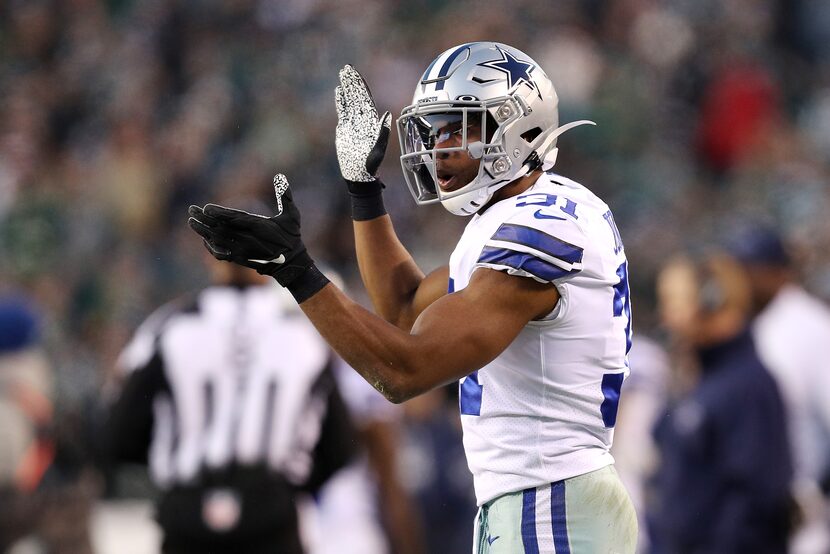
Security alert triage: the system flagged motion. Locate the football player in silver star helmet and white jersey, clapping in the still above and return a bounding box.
[190,42,637,554]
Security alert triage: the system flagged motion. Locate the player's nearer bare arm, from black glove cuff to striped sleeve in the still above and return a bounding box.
[300,269,559,402]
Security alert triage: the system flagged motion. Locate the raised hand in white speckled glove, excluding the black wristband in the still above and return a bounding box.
[334,65,392,182]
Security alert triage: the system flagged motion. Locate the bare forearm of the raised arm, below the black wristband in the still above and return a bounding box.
[354,215,424,330]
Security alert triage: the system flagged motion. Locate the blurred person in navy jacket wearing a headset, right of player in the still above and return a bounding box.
[650,256,792,554]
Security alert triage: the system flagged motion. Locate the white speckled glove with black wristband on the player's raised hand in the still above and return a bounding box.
[334,65,392,221]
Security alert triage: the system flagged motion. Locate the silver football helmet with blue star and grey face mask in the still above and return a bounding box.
[397,42,594,215]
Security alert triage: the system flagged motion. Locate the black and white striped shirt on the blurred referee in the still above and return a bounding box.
[108,285,353,489]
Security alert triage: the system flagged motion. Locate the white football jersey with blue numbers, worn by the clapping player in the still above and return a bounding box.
[449,173,631,505]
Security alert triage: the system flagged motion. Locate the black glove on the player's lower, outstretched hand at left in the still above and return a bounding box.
[187,173,328,302]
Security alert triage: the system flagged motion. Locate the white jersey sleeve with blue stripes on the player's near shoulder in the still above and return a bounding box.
[475,210,587,283]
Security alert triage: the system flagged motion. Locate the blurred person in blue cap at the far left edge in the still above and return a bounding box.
[0,295,96,554]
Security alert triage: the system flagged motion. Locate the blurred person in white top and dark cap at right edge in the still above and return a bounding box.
[732,225,830,554]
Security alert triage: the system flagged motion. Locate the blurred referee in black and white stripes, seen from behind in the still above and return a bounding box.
[105,252,356,554]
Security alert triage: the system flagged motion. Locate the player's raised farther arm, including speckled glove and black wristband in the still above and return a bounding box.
[335,65,448,330]
